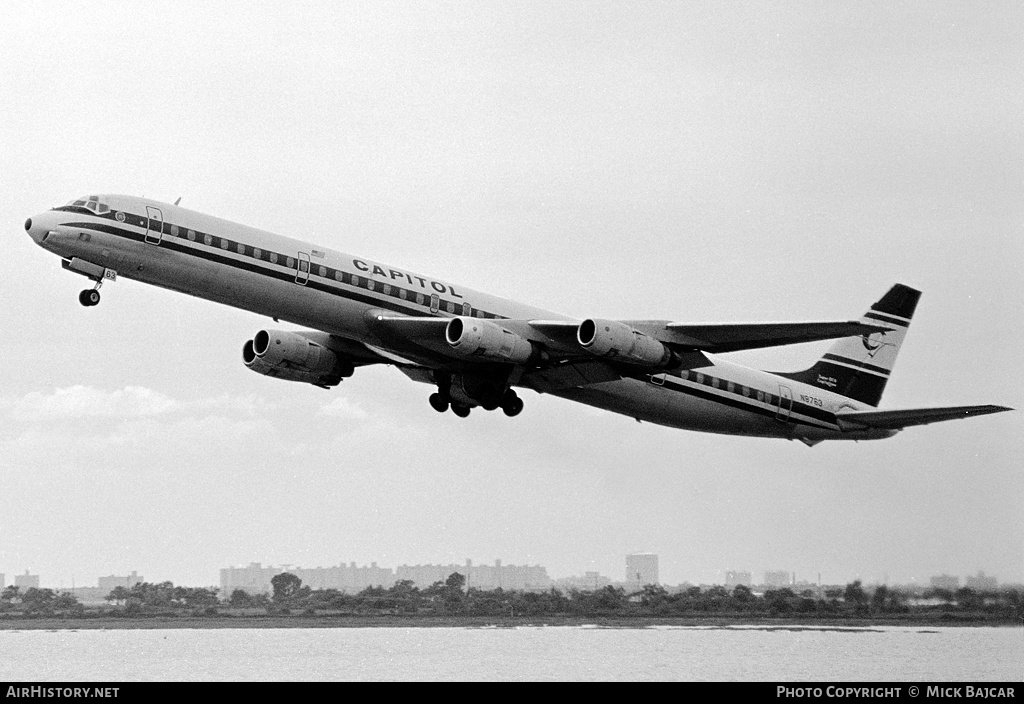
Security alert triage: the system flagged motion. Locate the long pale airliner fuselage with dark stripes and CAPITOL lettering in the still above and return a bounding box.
[28,195,894,443]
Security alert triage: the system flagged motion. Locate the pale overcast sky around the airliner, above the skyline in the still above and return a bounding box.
[0,0,1024,586]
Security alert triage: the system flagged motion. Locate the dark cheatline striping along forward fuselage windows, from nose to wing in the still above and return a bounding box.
[60,216,504,319]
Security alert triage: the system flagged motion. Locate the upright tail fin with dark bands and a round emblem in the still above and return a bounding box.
[778,283,921,406]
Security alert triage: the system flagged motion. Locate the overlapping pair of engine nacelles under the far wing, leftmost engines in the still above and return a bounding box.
[242,331,354,387]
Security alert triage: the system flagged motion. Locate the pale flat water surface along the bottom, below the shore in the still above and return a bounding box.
[0,626,1024,681]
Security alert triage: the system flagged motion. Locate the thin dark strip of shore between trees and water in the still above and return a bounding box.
[0,615,1022,630]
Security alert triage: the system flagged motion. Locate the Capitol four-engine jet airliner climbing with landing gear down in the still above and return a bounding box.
[25,194,1013,446]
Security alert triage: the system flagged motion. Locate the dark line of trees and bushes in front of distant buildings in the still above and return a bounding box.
[0,572,1024,619]
